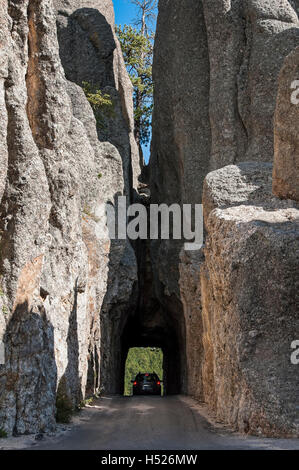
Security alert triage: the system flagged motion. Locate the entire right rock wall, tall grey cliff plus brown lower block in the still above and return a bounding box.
[151,0,299,436]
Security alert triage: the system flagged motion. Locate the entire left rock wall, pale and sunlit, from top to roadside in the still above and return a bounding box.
[0,0,138,434]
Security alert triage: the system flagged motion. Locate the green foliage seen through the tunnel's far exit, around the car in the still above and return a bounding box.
[124,348,163,396]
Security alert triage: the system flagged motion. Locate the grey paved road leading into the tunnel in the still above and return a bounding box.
[27,396,299,450]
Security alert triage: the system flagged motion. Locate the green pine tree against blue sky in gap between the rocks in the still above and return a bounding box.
[116,25,154,145]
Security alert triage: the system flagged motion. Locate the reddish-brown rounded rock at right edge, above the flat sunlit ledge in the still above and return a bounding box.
[273,47,299,201]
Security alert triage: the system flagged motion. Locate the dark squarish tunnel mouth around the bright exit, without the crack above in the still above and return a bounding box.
[100,302,187,396]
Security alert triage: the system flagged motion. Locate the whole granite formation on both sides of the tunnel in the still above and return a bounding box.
[0,0,299,436]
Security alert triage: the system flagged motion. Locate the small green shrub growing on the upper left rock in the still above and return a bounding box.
[82,82,115,128]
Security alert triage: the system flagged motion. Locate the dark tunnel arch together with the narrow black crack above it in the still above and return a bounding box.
[99,240,188,395]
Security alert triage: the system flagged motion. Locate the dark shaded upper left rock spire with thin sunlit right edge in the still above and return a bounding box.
[54,0,140,192]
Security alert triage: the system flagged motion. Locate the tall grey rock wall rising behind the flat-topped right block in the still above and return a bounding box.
[151,0,299,297]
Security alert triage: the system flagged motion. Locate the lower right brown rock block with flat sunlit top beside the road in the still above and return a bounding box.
[180,163,299,436]
